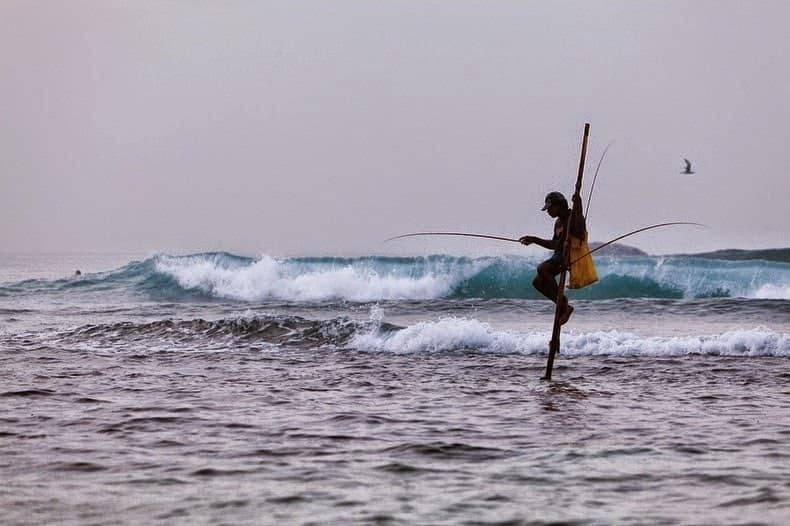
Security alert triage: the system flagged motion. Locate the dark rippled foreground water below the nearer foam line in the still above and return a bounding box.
[0,346,790,524]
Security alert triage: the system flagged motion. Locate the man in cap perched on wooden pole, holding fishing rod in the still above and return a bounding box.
[519,192,587,325]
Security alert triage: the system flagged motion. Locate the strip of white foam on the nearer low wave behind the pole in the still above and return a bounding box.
[351,318,790,356]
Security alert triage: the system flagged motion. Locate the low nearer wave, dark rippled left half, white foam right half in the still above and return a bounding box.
[15,314,790,358]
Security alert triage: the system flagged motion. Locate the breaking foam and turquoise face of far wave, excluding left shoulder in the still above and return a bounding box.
[154,254,790,301]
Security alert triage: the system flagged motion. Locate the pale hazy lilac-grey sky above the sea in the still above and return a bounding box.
[0,0,790,256]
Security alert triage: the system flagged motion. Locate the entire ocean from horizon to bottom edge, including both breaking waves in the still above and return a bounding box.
[0,252,790,525]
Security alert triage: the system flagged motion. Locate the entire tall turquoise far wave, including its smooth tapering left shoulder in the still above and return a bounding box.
[6,252,790,302]
